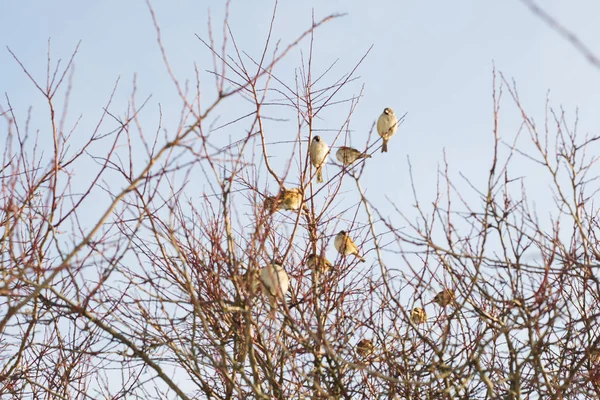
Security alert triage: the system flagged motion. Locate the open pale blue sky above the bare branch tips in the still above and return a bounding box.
[0,0,600,208]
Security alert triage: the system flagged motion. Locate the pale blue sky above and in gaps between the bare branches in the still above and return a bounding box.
[0,0,600,396]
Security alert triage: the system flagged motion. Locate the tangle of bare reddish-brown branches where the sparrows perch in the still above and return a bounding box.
[0,3,600,399]
